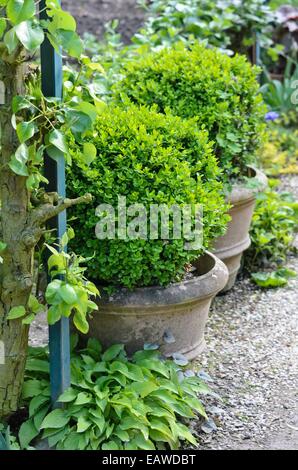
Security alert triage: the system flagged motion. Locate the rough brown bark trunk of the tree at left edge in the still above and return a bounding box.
[0,60,34,420]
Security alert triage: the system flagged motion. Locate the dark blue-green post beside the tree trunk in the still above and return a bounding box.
[40,0,70,405]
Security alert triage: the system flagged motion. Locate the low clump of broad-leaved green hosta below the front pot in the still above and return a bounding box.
[19,339,209,450]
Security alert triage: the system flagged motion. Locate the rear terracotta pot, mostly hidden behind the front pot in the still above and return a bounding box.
[213,169,267,292]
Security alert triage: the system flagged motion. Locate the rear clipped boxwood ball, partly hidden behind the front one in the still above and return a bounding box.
[114,43,266,180]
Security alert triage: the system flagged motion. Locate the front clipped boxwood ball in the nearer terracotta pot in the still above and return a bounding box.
[67,106,228,288]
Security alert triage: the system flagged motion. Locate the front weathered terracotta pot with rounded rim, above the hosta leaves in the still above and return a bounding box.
[89,253,228,359]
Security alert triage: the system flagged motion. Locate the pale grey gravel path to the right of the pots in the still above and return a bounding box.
[30,175,298,450]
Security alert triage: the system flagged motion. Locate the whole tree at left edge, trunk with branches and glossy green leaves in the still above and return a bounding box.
[0,0,100,419]
